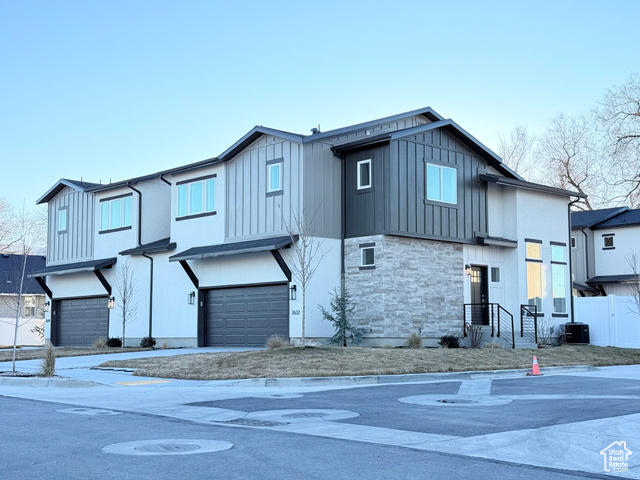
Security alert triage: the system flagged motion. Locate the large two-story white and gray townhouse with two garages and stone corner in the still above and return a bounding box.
[35,108,577,346]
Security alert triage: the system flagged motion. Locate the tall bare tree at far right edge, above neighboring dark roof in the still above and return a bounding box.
[595,74,640,208]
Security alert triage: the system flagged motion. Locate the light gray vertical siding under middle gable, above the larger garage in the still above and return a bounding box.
[226,135,302,239]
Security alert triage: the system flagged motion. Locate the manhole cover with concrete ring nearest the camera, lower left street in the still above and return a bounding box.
[102,439,233,455]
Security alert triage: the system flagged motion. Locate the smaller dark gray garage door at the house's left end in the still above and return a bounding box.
[57,297,109,346]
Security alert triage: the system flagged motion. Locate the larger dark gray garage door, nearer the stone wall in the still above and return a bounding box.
[205,284,289,347]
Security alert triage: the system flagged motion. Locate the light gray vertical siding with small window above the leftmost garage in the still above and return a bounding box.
[47,187,95,265]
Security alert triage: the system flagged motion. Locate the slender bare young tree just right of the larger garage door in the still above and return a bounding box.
[285,211,327,347]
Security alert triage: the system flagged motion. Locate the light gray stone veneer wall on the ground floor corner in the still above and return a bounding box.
[345,235,464,344]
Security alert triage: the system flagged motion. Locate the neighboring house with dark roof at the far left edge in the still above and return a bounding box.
[0,253,46,345]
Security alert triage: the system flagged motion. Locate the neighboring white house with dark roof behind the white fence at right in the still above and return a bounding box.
[571,207,640,297]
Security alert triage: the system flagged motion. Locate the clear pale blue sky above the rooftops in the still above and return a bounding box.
[0,0,640,208]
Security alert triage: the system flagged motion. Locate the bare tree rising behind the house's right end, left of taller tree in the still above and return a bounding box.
[537,113,606,210]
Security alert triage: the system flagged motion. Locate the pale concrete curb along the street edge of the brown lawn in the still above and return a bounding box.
[203,365,597,387]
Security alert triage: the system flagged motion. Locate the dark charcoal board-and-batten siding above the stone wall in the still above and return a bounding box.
[345,128,487,243]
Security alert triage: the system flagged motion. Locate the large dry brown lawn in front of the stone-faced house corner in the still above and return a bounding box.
[101,345,640,380]
